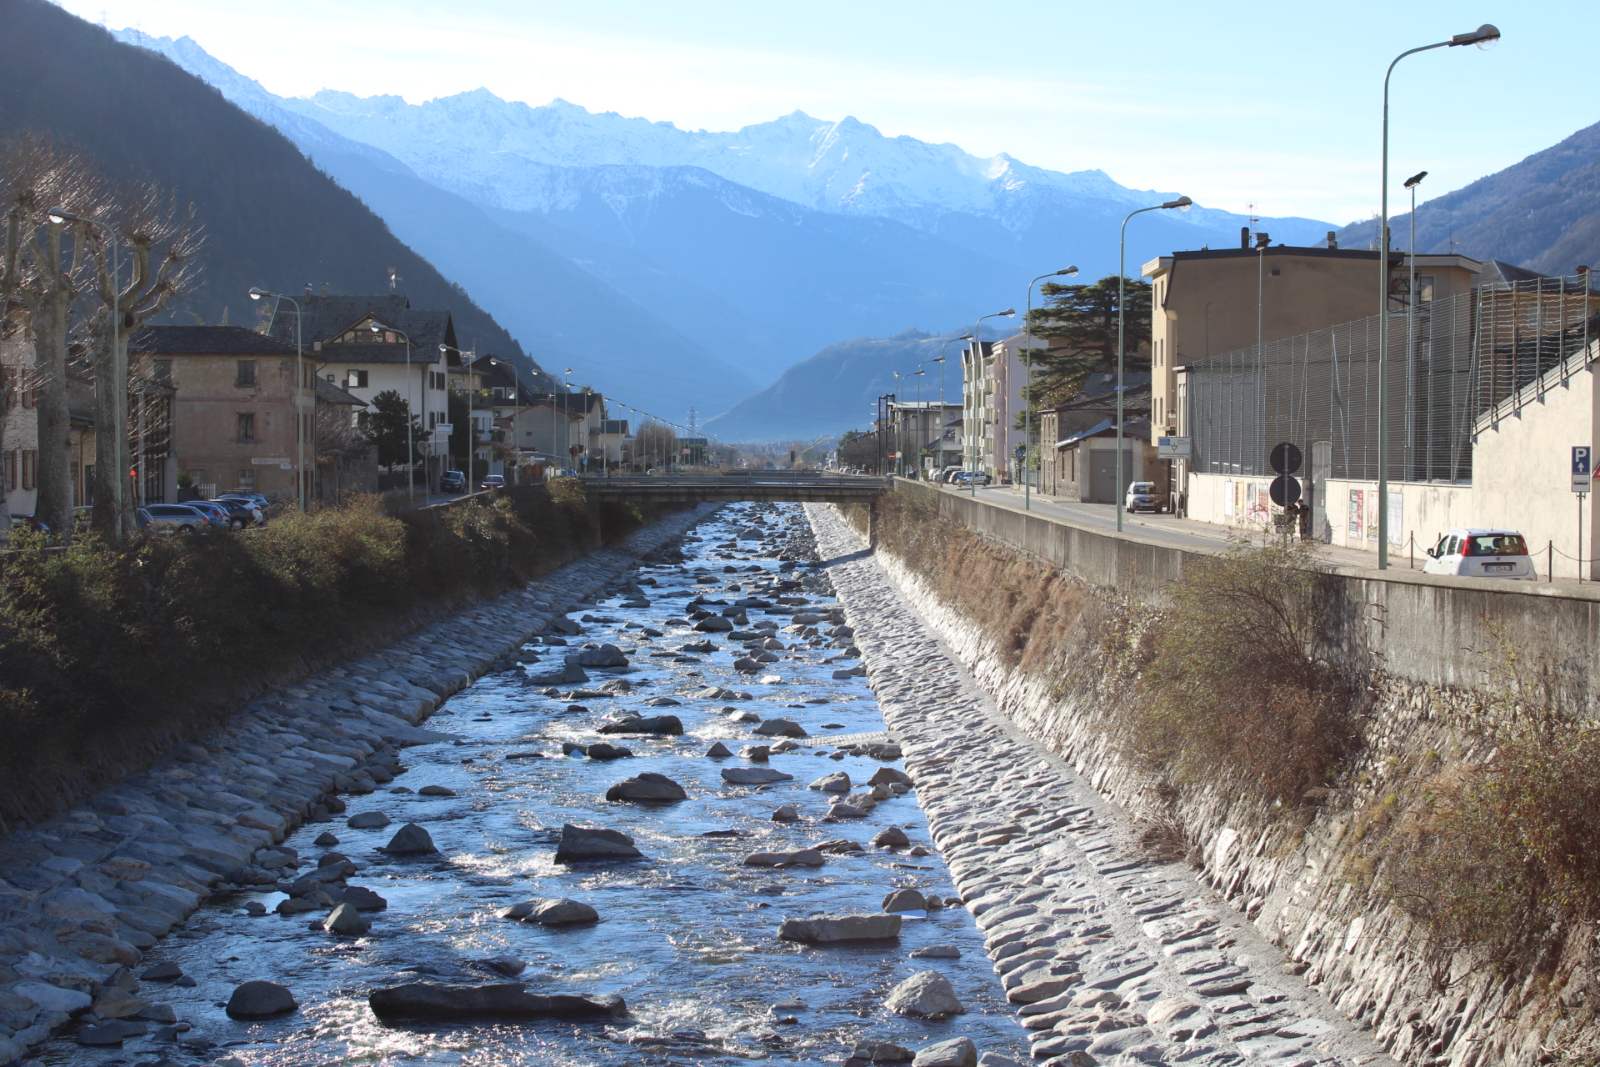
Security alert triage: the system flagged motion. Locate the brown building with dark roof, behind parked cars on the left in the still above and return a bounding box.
[128,326,317,502]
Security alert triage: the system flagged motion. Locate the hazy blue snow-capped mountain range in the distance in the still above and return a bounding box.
[120,30,1330,434]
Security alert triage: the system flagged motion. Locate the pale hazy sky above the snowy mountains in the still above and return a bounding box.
[53,0,1600,222]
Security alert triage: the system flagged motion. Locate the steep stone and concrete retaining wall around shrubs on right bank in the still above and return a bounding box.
[851,494,1595,1067]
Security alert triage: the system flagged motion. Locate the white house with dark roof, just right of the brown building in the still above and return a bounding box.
[267,293,461,485]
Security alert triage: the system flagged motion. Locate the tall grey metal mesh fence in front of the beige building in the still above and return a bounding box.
[1186,277,1600,482]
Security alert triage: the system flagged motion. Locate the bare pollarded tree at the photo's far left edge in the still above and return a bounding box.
[0,136,102,539]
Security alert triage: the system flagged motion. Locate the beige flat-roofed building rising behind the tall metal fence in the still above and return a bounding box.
[1141,234,1483,443]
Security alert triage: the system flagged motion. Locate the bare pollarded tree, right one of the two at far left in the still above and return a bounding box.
[74,186,202,541]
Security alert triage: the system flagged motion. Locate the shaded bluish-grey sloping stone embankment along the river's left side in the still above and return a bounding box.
[0,507,715,1064]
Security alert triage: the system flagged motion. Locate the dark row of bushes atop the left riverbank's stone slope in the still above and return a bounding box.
[0,486,665,829]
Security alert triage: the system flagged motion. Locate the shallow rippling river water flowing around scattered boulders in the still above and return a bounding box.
[42,504,1026,1065]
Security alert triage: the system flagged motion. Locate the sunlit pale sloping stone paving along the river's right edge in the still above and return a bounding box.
[808,506,1392,1065]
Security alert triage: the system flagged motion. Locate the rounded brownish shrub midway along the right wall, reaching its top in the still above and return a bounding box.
[1130,544,1358,805]
